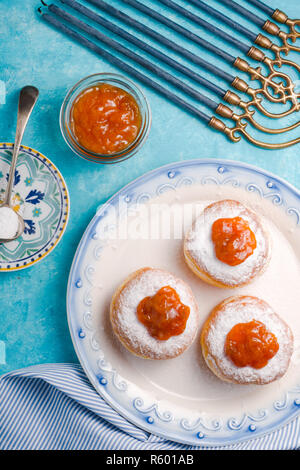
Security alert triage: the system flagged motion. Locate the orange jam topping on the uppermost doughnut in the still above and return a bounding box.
[212,217,256,266]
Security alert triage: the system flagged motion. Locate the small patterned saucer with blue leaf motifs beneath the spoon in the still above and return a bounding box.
[0,143,70,271]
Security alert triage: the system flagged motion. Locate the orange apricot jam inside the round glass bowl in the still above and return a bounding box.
[71,83,141,155]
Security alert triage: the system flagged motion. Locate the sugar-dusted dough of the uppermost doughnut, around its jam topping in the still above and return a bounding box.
[184,200,271,288]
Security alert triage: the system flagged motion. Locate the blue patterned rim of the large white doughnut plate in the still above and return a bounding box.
[67,159,300,446]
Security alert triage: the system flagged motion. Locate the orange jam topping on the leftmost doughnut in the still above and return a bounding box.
[137,286,190,341]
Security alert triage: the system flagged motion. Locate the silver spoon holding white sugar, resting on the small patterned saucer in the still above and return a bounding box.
[0,86,39,243]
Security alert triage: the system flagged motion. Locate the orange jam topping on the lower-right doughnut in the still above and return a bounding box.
[225,320,279,369]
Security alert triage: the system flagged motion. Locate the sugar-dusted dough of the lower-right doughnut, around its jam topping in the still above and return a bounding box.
[201,296,293,384]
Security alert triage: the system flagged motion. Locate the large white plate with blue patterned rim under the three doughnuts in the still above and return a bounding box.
[67,159,300,446]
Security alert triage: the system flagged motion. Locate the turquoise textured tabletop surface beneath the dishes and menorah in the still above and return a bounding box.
[0,0,300,373]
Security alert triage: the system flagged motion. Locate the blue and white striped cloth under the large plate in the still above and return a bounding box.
[0,364,300,450]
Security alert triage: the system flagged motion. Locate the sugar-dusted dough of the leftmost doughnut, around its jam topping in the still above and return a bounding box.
[110,267,199,359]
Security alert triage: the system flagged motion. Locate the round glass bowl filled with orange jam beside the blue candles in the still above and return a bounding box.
[60,73,151,163]
